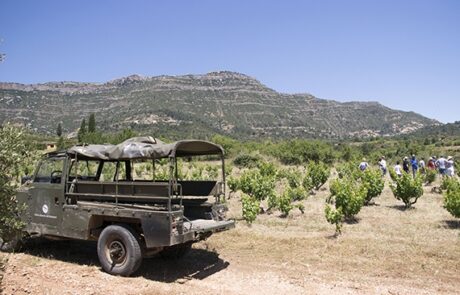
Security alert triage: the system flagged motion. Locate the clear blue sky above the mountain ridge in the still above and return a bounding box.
[0,0,460,122]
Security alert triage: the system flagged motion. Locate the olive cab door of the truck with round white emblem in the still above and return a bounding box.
[29,156,66,235]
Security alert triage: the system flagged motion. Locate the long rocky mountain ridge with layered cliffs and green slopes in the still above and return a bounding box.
[0,72,439,138]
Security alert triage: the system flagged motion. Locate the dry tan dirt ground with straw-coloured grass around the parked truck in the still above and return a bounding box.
[0,182,460,295]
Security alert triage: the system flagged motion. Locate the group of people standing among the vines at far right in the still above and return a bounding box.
[359,155,455,177]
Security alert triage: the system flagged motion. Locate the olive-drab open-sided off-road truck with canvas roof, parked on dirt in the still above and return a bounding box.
[17,137,234,276]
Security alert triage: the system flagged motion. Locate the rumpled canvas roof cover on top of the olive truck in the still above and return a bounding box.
[67,136,223,160]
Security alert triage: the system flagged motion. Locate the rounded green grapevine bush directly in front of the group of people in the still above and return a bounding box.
[390,172,423,209]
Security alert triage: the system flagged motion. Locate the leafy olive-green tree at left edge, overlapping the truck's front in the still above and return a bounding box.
[0,124,29,246]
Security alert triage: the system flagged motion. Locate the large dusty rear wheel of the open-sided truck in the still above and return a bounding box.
[97,225,142,276]
